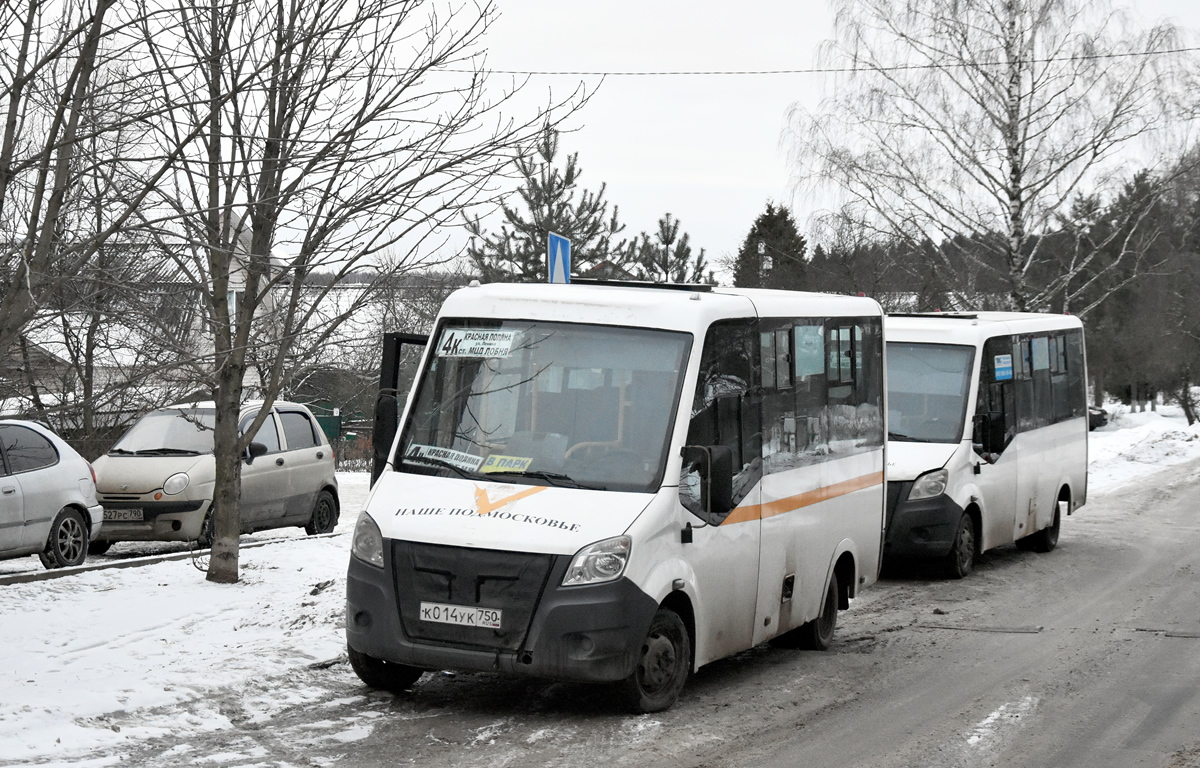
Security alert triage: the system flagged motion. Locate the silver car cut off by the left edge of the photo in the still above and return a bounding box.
[0,419,102,568]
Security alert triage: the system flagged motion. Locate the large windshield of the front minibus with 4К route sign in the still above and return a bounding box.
[395,320,691,492]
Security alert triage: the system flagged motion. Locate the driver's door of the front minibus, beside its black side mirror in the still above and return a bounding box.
[680,319,762,664]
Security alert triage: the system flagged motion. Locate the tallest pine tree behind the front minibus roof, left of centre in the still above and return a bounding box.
[467,127,632,282]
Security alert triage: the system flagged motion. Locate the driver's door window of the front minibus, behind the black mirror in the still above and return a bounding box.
[680,319,762,524]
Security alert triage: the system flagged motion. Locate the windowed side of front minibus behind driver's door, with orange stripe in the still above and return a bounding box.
[755,317,884,644]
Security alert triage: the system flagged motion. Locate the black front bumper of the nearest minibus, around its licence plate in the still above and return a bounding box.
[346,542,658,683]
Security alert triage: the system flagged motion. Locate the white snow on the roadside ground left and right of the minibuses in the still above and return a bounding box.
[7,406,1200,766]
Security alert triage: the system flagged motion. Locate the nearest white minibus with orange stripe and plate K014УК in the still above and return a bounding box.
[346,282,886,712]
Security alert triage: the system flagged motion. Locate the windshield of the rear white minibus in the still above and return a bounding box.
[888,341,974,443]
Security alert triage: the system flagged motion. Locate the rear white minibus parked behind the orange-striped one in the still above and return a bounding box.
[884,312,1087,578]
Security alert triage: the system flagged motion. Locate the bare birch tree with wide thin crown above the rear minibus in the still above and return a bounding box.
[791,0,1189,311]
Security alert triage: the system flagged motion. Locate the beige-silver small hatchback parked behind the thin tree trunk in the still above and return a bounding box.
[91,401,338,553]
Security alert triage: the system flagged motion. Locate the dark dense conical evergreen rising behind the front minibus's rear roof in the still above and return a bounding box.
[733,202,808,290]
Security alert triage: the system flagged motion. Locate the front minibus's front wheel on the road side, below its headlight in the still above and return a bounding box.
[617,608,691,714]
